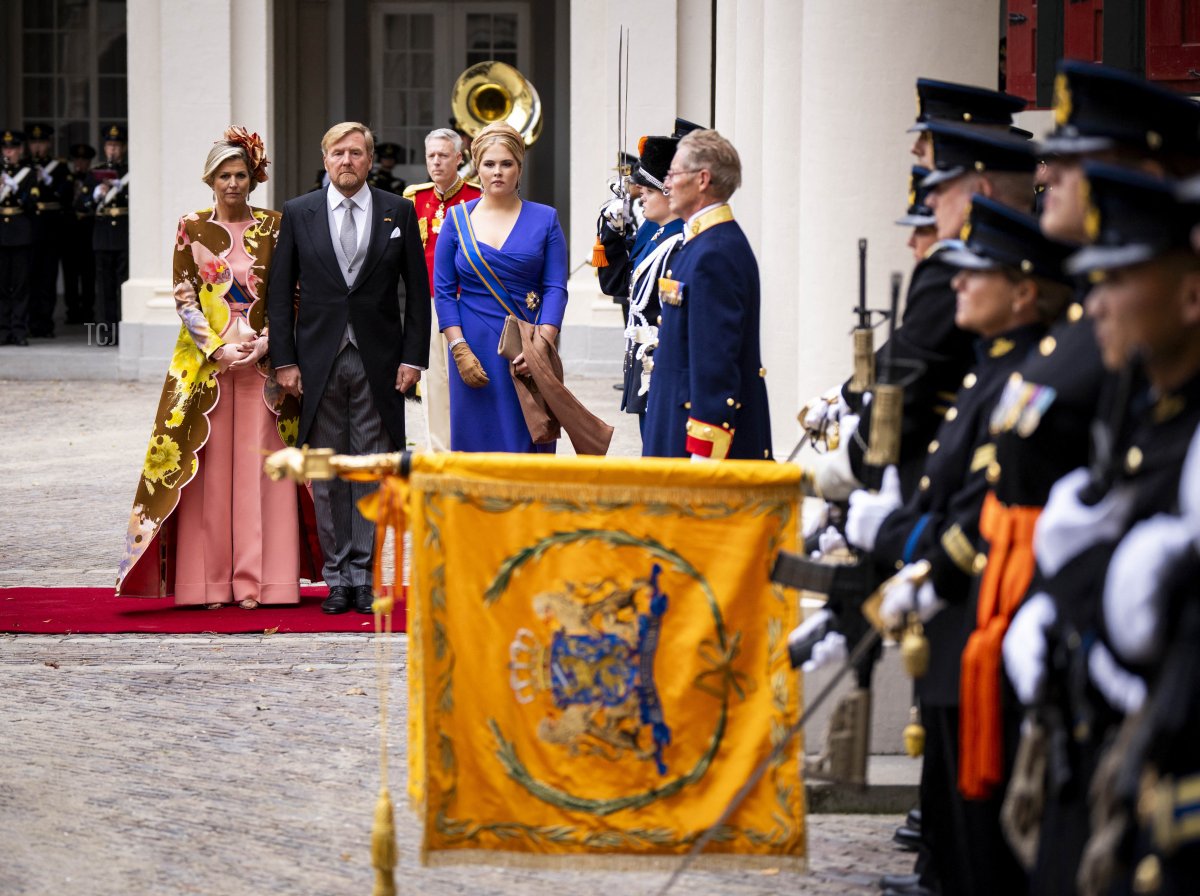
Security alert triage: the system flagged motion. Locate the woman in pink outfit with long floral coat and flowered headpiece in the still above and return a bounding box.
[116,127,320,609]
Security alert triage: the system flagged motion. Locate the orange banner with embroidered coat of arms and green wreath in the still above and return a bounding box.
[396,455,805,870]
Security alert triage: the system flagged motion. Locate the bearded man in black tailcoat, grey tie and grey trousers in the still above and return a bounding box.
[266,121,430,613]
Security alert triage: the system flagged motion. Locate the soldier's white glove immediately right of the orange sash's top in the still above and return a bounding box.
[1033,467,1133,576]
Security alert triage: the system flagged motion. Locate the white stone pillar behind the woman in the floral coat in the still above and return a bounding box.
[120,0,274,380]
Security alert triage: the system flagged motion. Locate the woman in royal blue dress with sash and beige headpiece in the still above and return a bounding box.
[433,122,566,453]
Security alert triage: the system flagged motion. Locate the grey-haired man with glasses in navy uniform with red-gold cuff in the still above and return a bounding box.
[642,131,770,461]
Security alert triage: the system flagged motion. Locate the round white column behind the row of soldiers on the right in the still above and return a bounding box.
[787,0,1000,449]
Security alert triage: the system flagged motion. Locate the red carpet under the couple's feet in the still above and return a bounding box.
[0,585,404,635]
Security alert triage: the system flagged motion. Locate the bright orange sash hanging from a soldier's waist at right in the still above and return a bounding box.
[959,492,1042,799]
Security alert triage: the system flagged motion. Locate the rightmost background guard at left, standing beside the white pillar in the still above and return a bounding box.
[85,125,130,345]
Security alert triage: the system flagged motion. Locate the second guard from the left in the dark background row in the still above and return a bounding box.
[25,122,73,339]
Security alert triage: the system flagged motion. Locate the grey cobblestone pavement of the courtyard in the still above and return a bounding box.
[0,380,911,896]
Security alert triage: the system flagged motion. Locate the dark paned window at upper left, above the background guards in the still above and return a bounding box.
[17,0,128,155]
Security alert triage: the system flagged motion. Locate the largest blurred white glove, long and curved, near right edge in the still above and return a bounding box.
[1104,513,1192,662]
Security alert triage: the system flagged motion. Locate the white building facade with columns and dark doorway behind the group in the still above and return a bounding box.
[10,0,1008,455]
